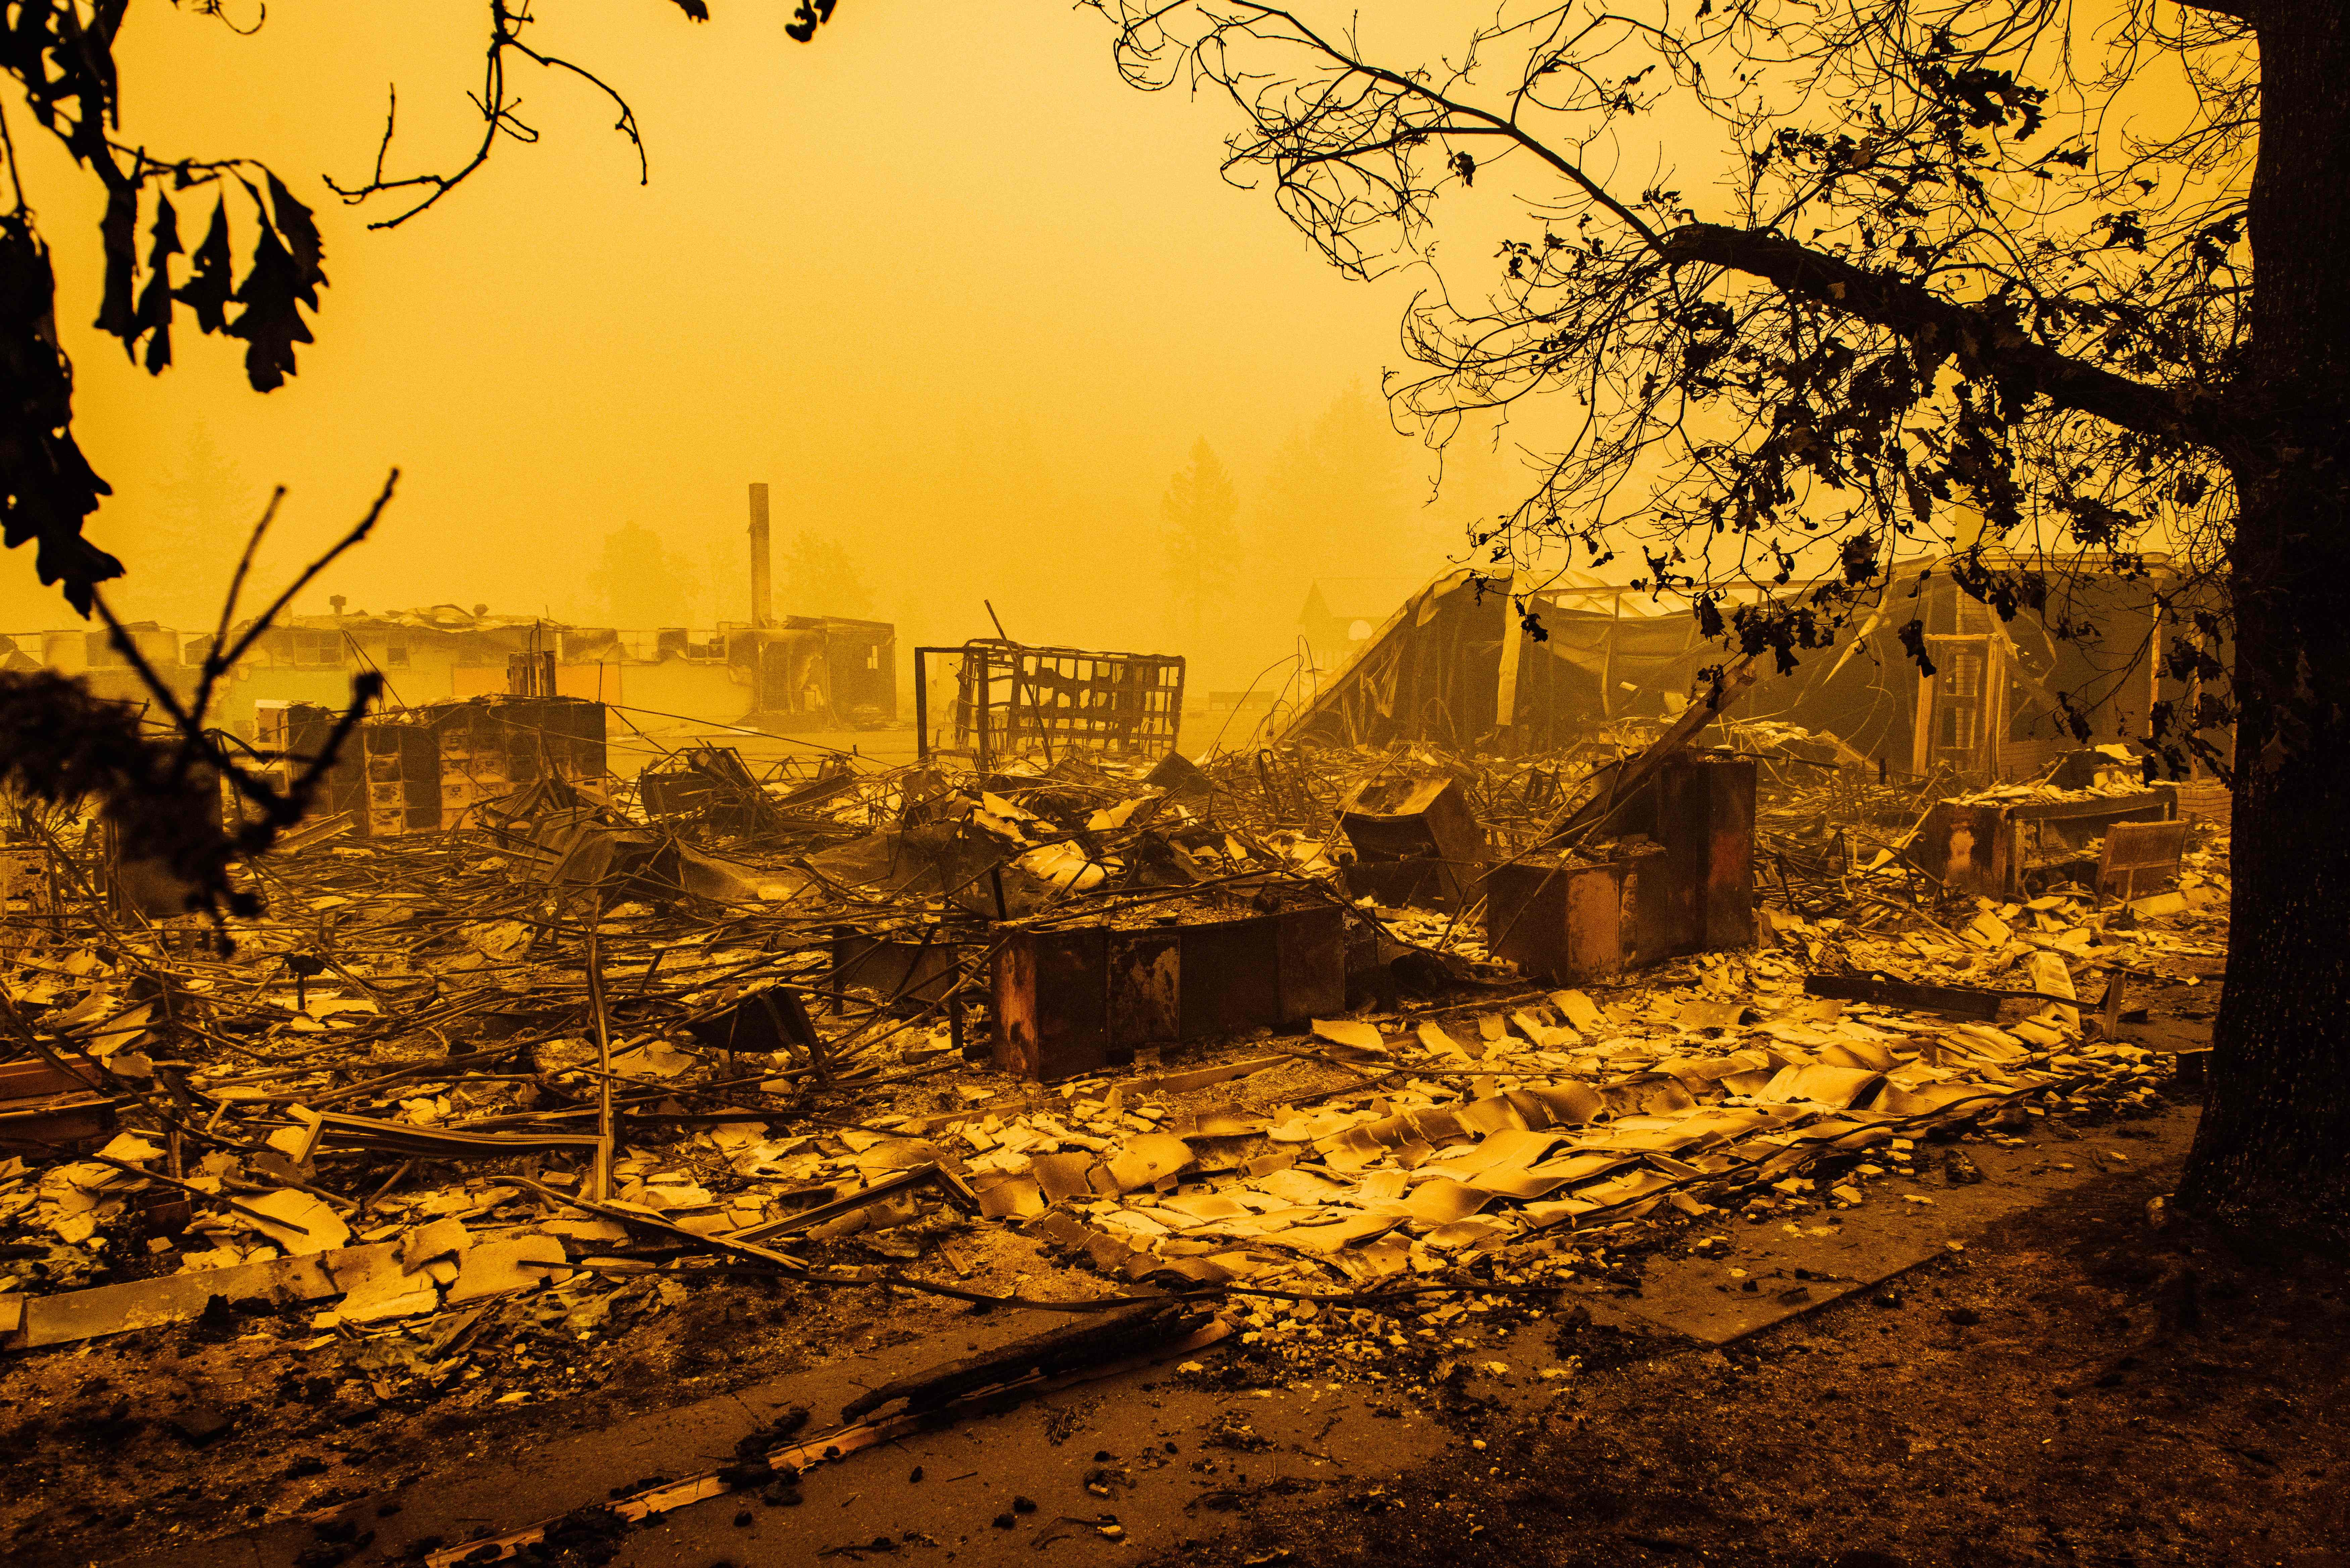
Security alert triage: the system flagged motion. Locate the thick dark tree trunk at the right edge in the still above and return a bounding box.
[2179,0,2350,1236]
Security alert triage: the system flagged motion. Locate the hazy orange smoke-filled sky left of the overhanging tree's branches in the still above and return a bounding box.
[0,0,1541,679]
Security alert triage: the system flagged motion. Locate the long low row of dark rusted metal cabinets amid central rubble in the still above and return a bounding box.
[992,905,1347,1079]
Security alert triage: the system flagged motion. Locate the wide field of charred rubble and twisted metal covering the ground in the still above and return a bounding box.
[0,715,2228,1399]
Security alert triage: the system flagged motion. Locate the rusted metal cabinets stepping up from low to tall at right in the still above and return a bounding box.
[1485,757,1755,985]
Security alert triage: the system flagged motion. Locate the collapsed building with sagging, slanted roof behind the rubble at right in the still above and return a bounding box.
[1279,557,2195,780]
